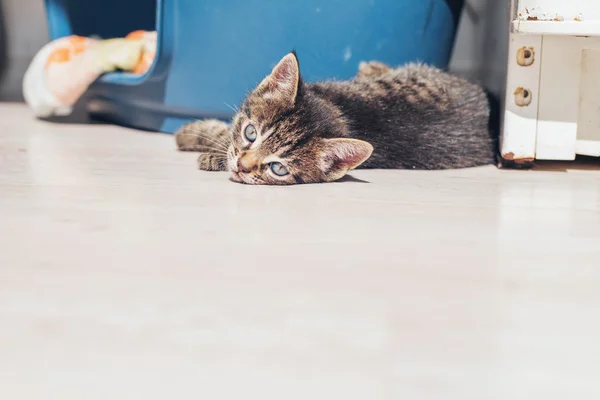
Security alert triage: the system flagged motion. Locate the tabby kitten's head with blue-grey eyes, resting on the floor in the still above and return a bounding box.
[228,53,373,185]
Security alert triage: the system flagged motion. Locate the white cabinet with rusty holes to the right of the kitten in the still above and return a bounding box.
[501,0,600,163]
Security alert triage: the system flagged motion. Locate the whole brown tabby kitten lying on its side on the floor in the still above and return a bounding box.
[175,53,496,185]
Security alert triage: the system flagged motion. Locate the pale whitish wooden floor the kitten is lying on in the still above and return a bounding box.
[0,104,600,400]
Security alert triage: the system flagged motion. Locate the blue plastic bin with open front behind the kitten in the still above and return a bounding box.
[46,0,463,133]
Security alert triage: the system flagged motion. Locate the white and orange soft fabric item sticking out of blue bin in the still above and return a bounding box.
[23,31,156,117]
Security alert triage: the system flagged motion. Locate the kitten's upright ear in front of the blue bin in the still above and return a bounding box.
[257,53,300,106]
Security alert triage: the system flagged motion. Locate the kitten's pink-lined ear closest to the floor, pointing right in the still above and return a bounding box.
[320,139,373,181]
